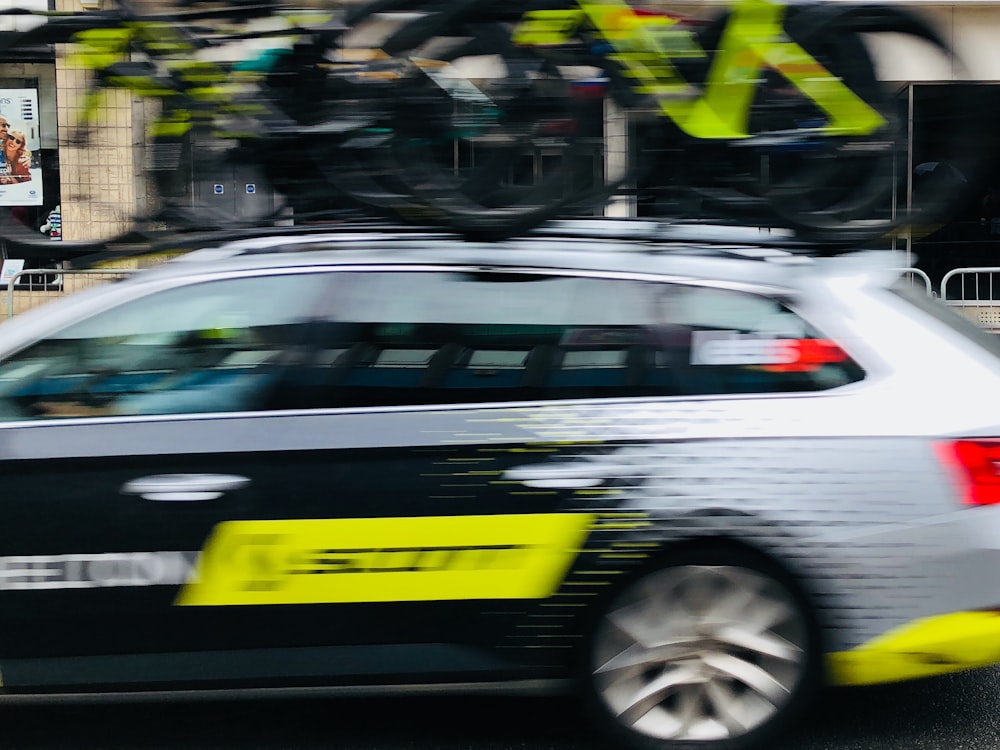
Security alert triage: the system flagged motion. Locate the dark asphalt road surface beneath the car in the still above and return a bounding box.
[0,667,1000,750]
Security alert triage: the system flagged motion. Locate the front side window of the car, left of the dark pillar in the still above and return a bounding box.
[0,273,329,419]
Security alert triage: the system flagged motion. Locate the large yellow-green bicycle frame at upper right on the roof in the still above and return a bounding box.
[514,0,886,139]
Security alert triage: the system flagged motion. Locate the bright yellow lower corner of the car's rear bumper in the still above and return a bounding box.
[828,612,1000,685]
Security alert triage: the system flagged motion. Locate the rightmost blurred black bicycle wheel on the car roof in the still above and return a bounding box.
[704,8,976,243]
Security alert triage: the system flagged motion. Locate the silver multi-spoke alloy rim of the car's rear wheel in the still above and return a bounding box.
[591,565,809,740]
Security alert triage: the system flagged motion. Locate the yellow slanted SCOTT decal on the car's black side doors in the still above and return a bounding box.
[177,513,595,606]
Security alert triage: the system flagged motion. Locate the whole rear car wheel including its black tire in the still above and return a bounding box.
[585,548,822,750]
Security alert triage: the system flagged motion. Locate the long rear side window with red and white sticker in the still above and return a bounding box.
[295,271,863,408]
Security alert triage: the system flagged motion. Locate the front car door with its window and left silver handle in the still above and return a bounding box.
[0,269,328,690]
